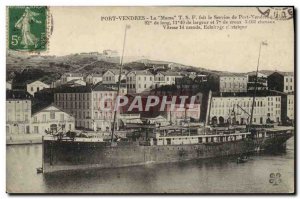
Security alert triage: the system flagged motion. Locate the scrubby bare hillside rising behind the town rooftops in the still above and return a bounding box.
[6,51,282,84]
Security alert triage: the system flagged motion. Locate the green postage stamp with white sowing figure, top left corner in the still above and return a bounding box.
[8,6,48,52]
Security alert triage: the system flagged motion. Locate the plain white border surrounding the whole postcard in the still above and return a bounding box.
[0,0,300,198]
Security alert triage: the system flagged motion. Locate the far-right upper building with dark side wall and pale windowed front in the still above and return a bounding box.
[268,71,295,93]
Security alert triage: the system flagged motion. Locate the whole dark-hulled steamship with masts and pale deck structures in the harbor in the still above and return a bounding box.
[41,26,294,173]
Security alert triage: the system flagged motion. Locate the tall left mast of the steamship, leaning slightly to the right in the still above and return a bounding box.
[111,25,130,143]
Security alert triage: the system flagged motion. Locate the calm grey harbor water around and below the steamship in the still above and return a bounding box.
[6,137,295,193]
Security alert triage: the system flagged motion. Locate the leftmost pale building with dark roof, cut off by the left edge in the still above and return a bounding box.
[6,90,31,134]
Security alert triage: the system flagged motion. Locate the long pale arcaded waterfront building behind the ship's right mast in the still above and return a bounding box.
[208,96,281,124]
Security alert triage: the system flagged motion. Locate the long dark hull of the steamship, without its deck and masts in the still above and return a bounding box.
[43,136,290,173]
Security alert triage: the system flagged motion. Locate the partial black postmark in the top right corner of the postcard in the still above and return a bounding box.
[257,7,294,20]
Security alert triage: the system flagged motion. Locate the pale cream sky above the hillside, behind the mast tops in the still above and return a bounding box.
[48,7,294,72]
